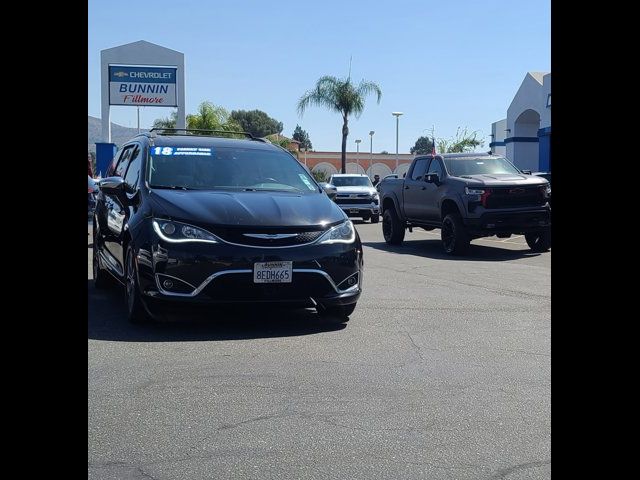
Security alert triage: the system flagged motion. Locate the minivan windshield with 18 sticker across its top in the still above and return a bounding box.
[147,147,319,193]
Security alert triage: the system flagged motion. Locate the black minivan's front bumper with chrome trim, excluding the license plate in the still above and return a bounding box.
[137,236,363,307]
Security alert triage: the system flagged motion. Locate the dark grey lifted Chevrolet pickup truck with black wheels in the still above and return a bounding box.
[380,153,551,255]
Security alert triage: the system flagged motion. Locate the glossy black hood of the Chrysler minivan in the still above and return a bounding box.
[150,189,346,227]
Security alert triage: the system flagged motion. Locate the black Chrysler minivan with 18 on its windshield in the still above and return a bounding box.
[93,130,363,323]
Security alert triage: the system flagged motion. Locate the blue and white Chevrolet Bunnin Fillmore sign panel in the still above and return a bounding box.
[109,65,178,107]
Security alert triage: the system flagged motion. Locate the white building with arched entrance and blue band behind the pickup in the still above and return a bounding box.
[489,72,551,172]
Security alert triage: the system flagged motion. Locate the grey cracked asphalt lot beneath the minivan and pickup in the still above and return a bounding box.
[87,223,551,480]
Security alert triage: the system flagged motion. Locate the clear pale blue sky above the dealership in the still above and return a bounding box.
[88,0,551,153]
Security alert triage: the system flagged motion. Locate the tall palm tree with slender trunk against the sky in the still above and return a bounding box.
[298,75,382,173]
